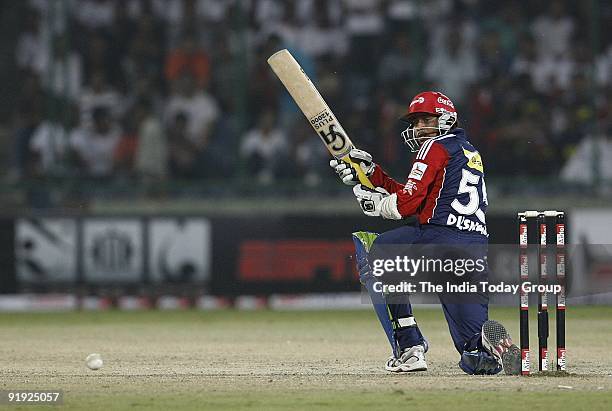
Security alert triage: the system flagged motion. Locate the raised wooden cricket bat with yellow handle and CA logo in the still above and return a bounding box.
[268,49,374,188]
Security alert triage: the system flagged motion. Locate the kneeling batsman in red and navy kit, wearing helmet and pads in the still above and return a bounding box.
[330,91,521,374]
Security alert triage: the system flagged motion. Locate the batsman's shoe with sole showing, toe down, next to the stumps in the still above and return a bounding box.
[482,320,521,375]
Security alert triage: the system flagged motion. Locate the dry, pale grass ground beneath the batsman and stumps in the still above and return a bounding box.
[0,307,612,411]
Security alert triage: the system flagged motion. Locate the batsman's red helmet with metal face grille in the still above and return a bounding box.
[402,91,457,152]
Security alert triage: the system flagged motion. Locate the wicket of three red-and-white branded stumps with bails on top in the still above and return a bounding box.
[518,211,566,375]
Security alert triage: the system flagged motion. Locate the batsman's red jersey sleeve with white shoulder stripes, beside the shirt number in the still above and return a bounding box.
[396,141,450,218]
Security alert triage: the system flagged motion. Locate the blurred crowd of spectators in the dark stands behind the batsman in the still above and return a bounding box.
[11,0,612,198]
